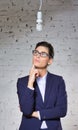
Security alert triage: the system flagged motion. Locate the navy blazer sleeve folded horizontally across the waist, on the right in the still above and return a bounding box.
[40,78,67,120]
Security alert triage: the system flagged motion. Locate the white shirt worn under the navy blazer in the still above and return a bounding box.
[37,73,47,129]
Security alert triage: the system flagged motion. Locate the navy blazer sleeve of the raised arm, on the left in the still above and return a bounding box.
[17,78,34,116]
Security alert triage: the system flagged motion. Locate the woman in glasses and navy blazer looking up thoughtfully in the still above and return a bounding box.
[17,41,67,130]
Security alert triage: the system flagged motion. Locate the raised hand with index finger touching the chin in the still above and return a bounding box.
[28,65,39,88]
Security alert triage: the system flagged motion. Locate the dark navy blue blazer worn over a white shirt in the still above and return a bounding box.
[17,72,67,130]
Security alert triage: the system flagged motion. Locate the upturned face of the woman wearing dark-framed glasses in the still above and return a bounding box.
[32,46,52,69]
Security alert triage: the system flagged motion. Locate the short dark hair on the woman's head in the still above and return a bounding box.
[35,41,54,58]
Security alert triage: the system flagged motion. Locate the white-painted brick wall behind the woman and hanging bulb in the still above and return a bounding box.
[0,0,78,130]
